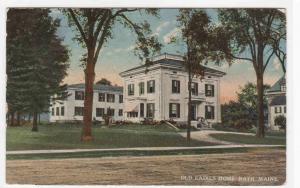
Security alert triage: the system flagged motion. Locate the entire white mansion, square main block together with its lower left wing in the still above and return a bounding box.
[50,54,225,123]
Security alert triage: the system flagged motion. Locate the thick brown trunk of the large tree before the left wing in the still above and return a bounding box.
[81,60,95,141]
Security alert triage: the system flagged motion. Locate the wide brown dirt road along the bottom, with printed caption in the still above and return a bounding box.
[6,149,286,185]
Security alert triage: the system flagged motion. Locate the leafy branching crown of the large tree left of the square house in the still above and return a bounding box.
[62,8,162,64]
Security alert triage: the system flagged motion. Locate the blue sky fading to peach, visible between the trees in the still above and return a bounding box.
[51,9,283,103]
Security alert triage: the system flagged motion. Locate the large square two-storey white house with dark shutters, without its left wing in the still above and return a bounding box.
[120,54,225,123]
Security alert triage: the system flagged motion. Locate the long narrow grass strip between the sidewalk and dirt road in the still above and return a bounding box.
[6,147,285,160]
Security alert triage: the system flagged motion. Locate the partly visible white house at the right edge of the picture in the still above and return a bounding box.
[266,76,286,130]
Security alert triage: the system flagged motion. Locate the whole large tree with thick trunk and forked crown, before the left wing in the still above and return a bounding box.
[64,8,161,141]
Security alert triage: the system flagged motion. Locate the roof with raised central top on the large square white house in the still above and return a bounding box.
[120,53,226,75]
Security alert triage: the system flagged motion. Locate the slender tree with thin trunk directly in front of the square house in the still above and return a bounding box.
[172,9,223,143]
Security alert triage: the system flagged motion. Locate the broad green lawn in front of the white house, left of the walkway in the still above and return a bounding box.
[6,124,212,151]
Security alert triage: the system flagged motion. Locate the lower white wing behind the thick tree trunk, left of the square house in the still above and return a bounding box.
[49,84,123,122]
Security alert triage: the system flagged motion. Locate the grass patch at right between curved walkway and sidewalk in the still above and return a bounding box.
[210,133,286,145]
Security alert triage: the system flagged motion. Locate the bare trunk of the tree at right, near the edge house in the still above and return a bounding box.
[256,73,265,137]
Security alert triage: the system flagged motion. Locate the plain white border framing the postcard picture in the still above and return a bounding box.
[0,0,300,187]
